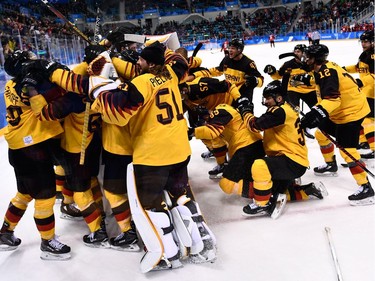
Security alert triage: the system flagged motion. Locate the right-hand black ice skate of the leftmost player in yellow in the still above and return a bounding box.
[40,235,71,260]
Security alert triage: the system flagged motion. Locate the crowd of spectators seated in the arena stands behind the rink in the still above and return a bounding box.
[0,0,373,58]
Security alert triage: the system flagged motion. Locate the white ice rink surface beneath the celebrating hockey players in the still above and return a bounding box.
[0,40,375,281]
